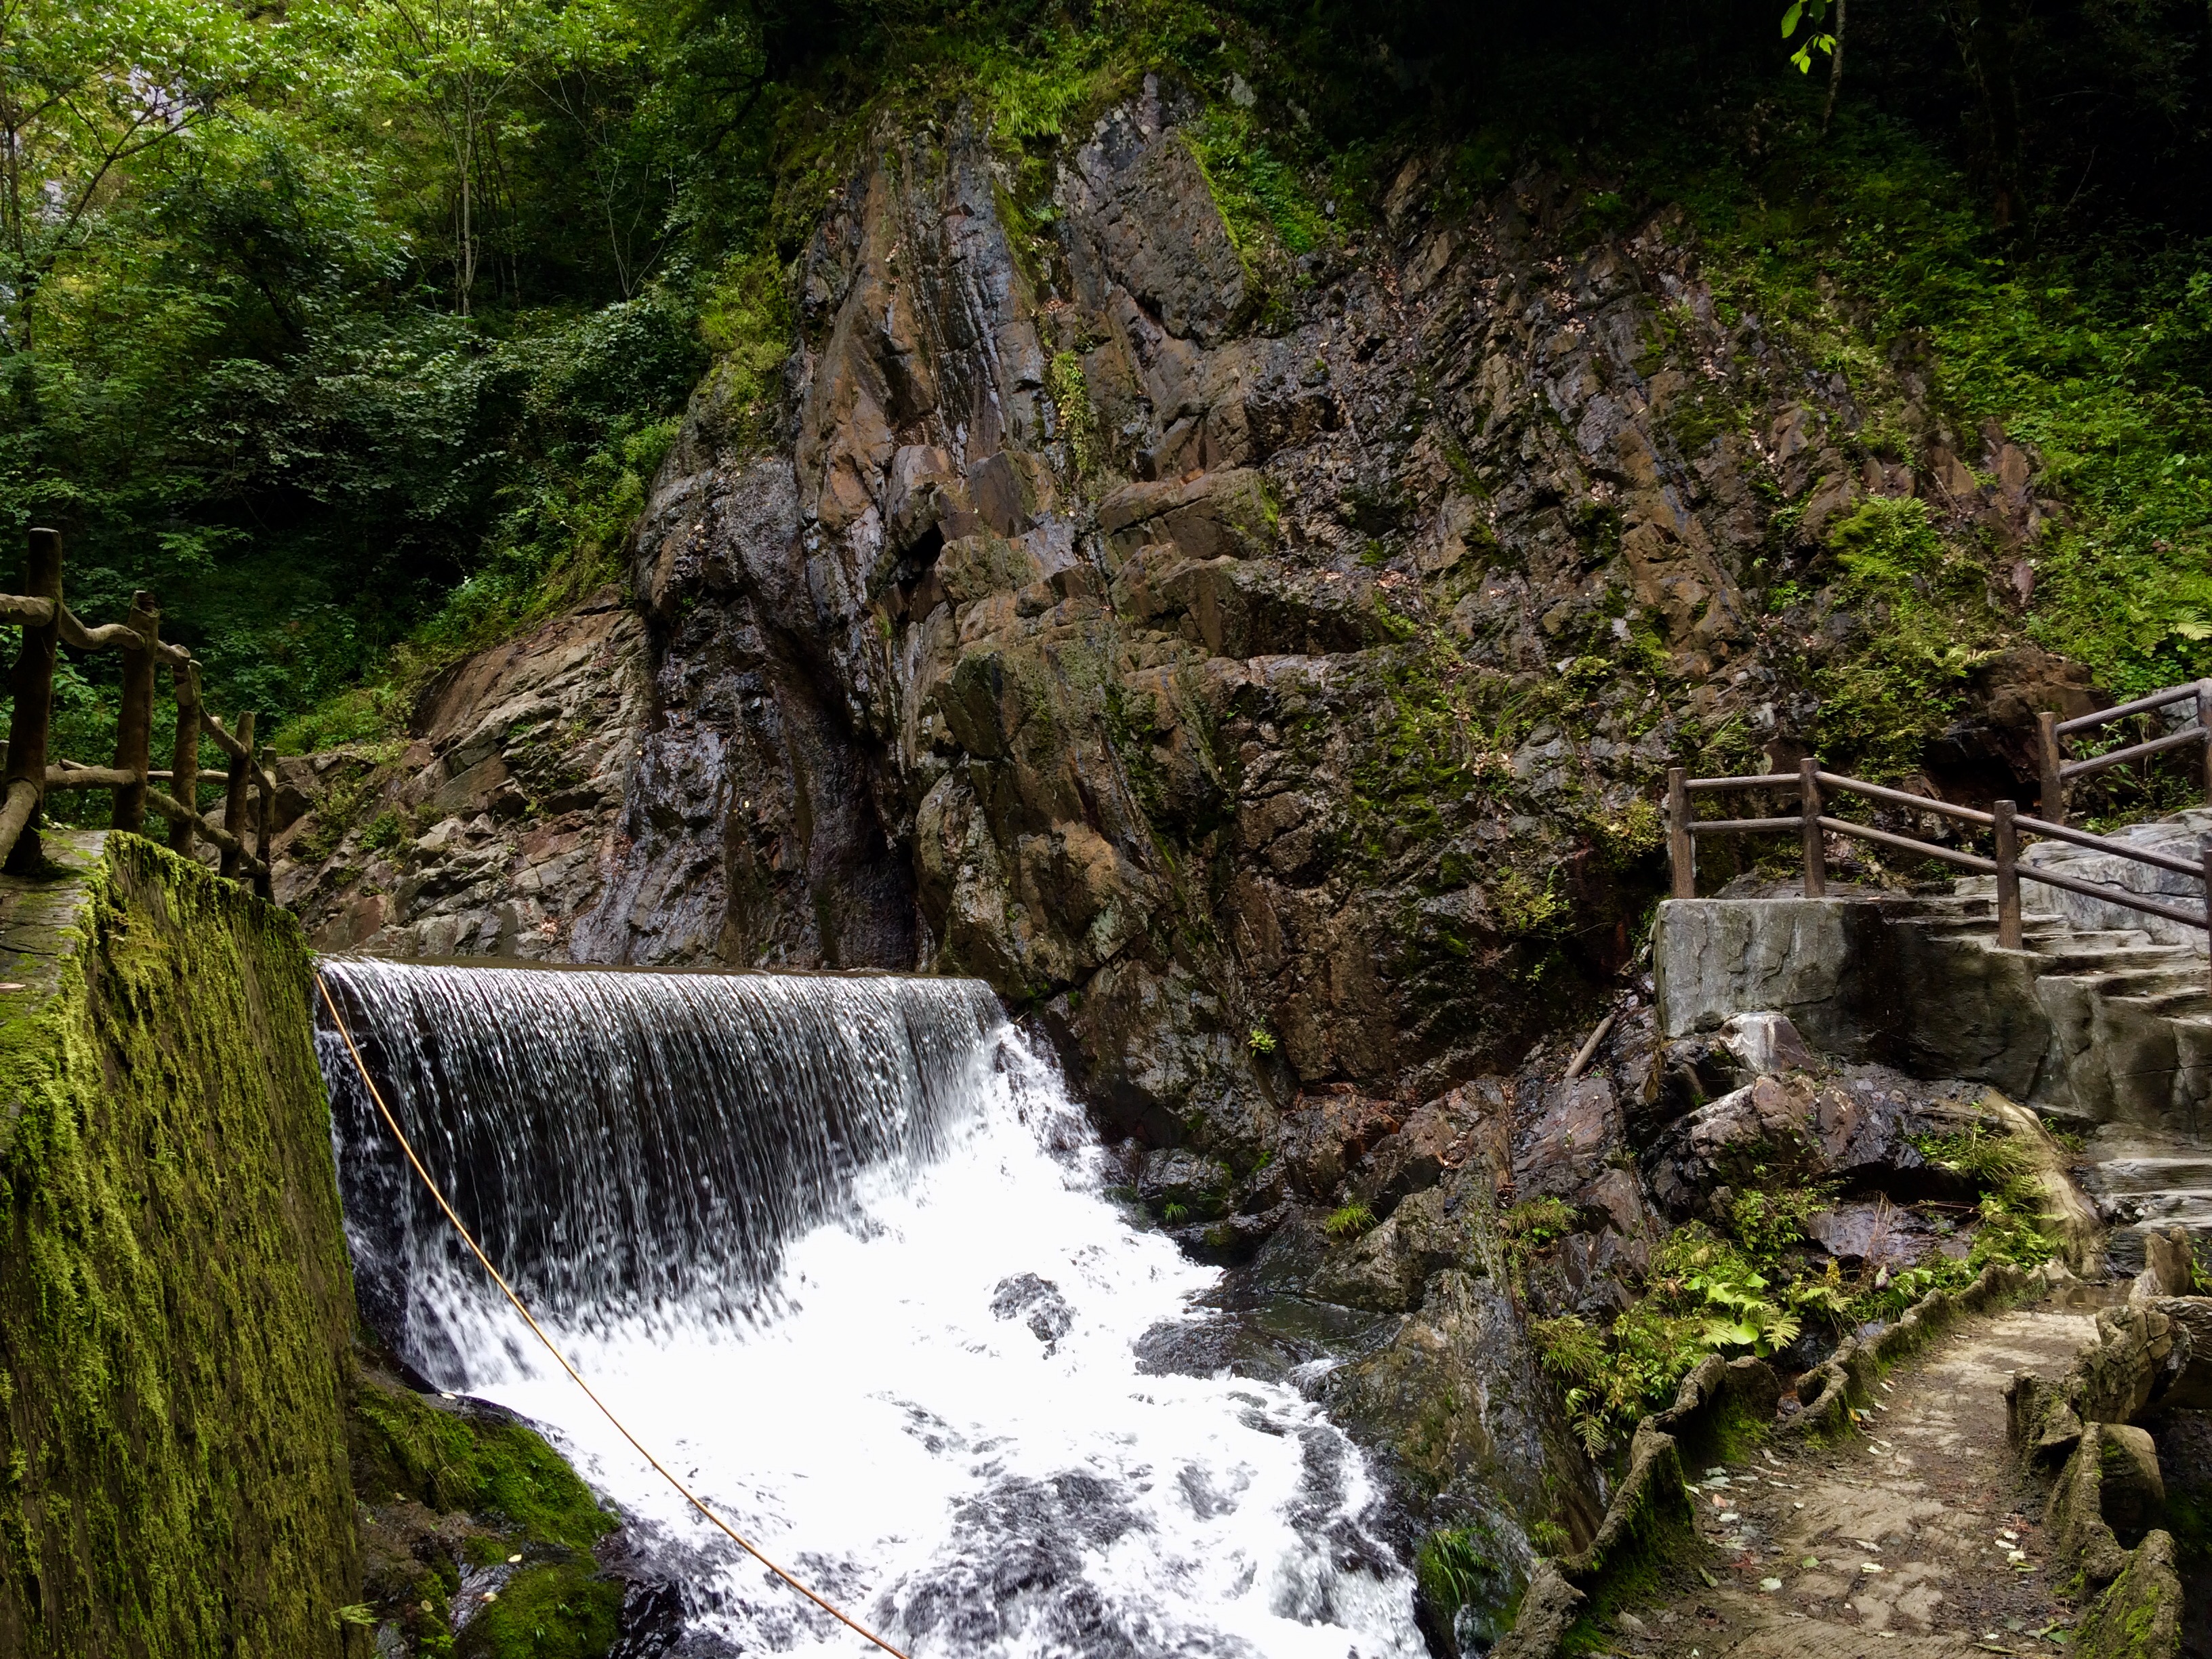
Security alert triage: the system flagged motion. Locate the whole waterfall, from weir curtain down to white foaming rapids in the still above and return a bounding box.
[321,960,1425,1659]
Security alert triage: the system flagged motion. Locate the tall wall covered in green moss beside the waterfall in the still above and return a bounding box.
[0,834,367,1659]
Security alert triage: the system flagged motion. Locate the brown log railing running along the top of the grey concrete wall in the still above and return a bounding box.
[1666,765,2212,995]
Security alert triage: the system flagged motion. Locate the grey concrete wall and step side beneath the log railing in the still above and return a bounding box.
[1652,898,2212,1128]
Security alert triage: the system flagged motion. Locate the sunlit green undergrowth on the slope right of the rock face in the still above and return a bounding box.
[1648,115,2212,703]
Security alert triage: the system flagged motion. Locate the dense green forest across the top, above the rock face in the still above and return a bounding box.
[0,0,2212,745]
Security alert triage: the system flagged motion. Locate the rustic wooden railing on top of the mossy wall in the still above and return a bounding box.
[0,529,276,898]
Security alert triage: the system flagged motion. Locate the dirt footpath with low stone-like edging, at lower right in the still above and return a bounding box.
[1612,1312,2097,1659]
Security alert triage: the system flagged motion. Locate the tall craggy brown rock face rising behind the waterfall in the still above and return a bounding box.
[290,71,2008,1170]
